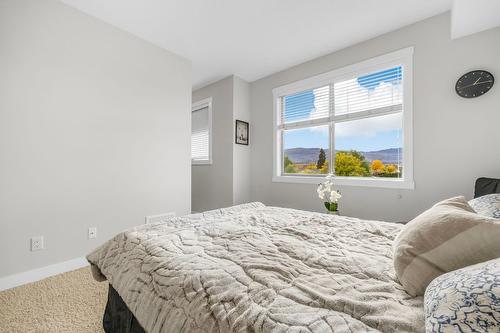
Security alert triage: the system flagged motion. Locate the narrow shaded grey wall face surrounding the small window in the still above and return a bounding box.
[191,76,234,212]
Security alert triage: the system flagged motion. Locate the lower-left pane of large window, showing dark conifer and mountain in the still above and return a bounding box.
[282,125,330,175]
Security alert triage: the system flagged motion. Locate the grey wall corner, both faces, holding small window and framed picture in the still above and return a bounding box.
[191,75,253,212]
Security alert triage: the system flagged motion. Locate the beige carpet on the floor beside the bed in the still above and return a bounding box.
[0,267,108,333]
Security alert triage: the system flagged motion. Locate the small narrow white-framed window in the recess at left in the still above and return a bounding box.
[191,98,212,164]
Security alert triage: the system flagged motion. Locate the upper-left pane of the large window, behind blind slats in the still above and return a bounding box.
[281,86,330,123]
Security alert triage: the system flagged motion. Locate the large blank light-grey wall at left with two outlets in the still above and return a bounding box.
[0,0,191,276]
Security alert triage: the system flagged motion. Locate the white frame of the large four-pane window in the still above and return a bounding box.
[272,47,415,189]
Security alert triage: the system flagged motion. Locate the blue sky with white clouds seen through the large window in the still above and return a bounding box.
[284,67,402,151]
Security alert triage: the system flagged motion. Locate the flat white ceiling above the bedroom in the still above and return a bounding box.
[62,0,452,88]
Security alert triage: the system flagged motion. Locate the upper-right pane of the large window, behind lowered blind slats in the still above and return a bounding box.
[334,66,403,115]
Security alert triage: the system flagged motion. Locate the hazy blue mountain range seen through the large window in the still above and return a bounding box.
[285,148,403,164]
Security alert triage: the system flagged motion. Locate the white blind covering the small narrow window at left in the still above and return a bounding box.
[191,106,210,161]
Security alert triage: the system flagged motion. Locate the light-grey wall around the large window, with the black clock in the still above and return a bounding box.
[251,13,500,221]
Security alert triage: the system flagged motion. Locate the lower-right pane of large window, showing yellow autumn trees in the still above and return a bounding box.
[335,113,403,178]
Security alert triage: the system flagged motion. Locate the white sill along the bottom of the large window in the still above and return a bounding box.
[272,176,415,190]
